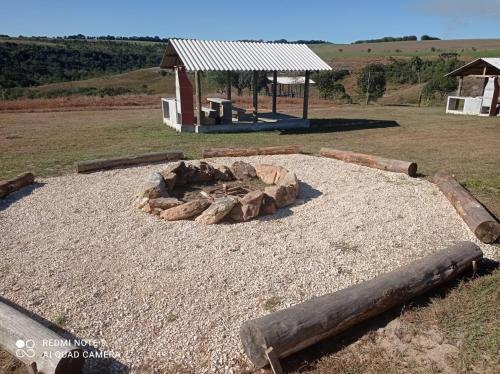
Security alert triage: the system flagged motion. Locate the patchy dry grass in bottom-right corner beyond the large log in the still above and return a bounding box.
[285,270,500,374]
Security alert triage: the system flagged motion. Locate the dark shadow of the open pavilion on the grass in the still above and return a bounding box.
[280,118,399,135]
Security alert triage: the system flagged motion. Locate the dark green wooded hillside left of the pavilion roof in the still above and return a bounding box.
[0,40,165,90]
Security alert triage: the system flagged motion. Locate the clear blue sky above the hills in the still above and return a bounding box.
[0,0,500,43]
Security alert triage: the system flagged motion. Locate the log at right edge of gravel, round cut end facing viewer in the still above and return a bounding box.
[434,172,500,243]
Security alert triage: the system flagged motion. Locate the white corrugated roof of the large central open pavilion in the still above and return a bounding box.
[160,39,331,71]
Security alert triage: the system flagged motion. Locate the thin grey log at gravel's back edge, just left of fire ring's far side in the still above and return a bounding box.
[75,151,184,173]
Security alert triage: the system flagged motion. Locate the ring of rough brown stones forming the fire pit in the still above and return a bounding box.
[136,161,299,224]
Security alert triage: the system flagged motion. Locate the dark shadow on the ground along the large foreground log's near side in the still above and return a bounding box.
[281,258,499,373]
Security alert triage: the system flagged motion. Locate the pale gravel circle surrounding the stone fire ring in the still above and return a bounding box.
[0,155,500,373]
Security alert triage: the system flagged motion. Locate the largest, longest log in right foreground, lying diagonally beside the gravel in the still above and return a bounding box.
[240,242,483,368]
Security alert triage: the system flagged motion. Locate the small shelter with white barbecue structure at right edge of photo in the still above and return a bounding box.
[446,58,500,116]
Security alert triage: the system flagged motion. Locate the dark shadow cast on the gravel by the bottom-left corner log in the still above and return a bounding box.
[0,296,130,374]
